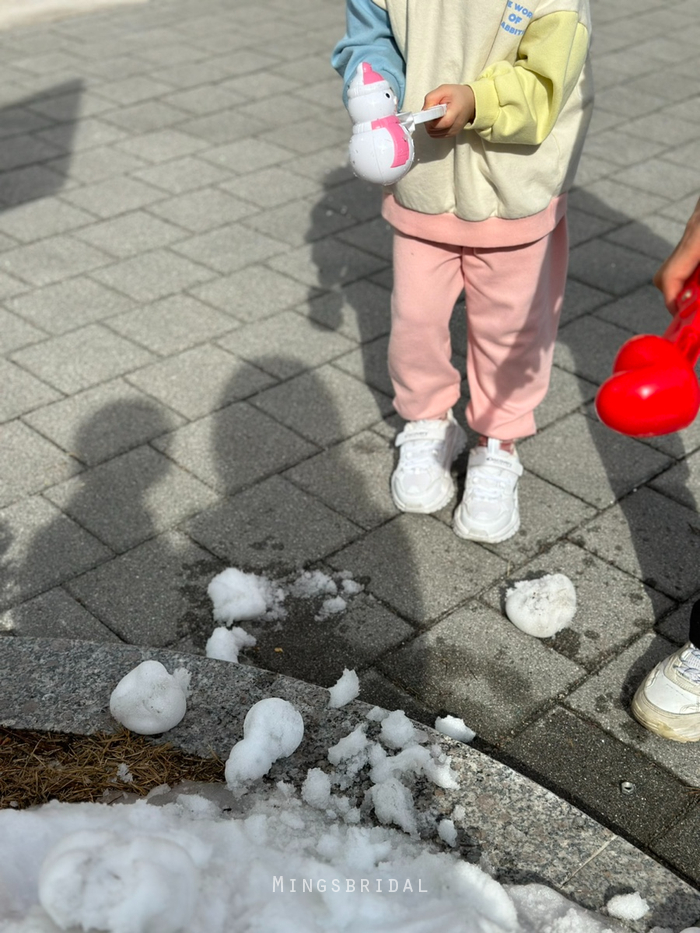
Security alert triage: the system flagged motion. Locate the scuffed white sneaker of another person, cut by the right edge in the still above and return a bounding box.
[632,642,700,742]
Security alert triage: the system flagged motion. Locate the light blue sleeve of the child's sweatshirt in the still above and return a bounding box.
[331,0,406,108]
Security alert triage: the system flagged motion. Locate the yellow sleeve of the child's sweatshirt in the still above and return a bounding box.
[467,12,589,146]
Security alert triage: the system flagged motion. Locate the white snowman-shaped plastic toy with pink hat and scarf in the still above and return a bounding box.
[348,62,447,185]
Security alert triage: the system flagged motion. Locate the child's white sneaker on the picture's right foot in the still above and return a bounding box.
[453,437,523,544]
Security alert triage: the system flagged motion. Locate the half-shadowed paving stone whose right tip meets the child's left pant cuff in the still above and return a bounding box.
[253,365,392,447]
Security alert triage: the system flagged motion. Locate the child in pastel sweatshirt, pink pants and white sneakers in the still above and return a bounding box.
[332,0,592,542]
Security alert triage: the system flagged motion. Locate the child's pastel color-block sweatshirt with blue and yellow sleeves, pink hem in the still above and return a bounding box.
[332,0,593,247]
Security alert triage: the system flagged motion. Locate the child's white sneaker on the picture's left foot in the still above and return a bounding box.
[391,411,467,513]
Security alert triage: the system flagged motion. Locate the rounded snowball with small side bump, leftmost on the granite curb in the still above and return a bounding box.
[109,661,190,735]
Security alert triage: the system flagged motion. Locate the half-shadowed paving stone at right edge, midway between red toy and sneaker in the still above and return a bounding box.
[579,487,700,599]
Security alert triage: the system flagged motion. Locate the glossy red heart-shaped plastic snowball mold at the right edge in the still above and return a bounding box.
[595,266,700,437]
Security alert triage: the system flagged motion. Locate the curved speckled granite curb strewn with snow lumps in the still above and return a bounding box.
[0,638,700,931]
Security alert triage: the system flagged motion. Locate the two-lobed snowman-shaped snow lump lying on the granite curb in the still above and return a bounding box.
[225,697,304,789]
